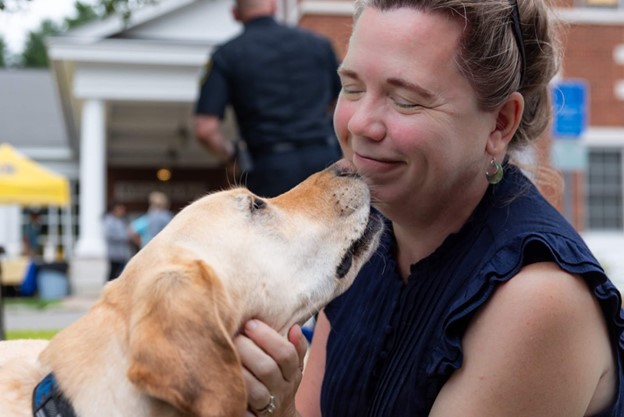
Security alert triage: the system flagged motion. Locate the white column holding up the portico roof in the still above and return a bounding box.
[70,99,106,295]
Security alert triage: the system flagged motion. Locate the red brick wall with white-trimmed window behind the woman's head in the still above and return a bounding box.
[300,0,624,288]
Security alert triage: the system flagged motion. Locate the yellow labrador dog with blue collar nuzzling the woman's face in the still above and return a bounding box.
[0,161,382,417]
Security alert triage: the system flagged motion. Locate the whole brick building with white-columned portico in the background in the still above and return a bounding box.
[0,0,624,293]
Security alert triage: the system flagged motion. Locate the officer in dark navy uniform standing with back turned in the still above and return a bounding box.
[195,0,340,197]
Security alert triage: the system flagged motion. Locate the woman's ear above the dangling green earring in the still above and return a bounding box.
[486,91,524,159]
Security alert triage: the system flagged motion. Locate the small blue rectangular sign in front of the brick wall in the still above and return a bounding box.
[552,80,587,139]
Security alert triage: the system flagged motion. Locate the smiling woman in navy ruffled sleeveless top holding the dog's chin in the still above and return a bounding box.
[236,0,624,417]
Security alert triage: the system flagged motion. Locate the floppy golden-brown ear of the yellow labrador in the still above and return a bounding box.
[128,261,247,417]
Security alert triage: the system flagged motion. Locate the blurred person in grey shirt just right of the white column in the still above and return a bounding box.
[104,202,132,281]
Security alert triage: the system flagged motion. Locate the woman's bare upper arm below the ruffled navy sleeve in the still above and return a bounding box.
[430,263,616,417]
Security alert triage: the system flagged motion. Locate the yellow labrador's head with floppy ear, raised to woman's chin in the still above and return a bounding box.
[121,161,382,416]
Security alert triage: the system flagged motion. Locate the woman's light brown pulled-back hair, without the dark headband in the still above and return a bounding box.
[354,0,560,150]
